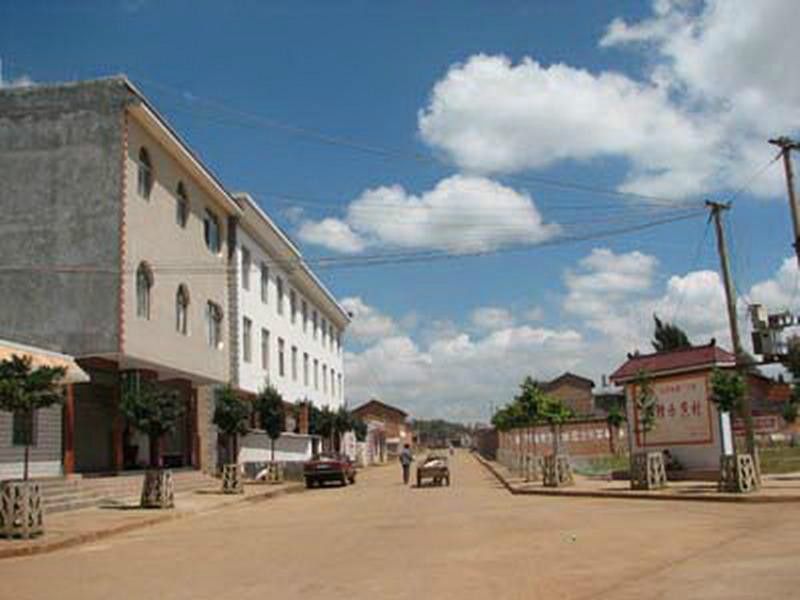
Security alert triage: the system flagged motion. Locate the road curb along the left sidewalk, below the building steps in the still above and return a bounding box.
[0,483,305,560]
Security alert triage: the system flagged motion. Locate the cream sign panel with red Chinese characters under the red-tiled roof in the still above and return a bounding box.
[637,376,713,446]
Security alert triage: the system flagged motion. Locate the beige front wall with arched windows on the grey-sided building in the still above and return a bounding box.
[123,116,229,382]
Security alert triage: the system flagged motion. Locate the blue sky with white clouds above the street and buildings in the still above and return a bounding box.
[0,0,800,421]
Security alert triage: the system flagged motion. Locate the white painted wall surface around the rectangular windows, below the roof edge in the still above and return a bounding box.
[236,228,344,408]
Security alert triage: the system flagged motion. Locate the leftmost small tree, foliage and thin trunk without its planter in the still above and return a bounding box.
[0,354,67,481]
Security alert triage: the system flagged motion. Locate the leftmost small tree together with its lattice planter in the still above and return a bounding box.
[0,354,66,538]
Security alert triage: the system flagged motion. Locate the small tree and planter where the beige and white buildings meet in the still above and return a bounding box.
[213,385,250,494]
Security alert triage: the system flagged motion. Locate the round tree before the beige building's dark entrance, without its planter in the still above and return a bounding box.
[119,376,183,468]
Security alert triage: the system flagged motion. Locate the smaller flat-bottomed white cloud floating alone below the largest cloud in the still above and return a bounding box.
[299,175,558,253]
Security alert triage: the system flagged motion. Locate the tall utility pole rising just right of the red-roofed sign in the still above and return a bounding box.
[706,200,761,464]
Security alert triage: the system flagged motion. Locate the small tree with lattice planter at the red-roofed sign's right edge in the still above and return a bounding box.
[710,369,758,492]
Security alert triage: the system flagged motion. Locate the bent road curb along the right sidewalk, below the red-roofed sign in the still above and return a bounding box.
[474,453,800,504]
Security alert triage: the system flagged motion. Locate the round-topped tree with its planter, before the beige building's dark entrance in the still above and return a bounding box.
[120,374,183,508]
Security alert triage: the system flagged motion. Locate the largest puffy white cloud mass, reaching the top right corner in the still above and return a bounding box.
[418,0,800,197]
